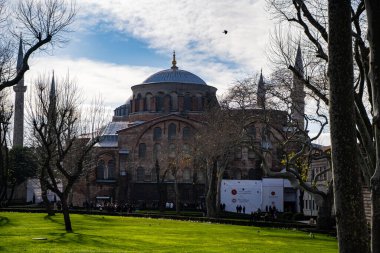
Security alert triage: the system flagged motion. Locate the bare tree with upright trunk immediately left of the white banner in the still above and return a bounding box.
[193,106,242,217]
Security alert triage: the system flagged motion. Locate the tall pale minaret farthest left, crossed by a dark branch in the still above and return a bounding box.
[13,37,26,147]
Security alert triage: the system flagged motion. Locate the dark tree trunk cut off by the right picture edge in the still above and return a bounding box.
[365,0,380,253]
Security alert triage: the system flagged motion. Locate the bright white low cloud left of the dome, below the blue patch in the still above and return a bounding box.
[26,56,158,108]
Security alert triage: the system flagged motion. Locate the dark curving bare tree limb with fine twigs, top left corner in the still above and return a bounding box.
[0,0,76,90]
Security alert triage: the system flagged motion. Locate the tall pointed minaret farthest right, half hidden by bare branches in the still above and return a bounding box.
[290,44,305,130]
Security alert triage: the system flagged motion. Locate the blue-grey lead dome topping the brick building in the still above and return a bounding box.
[143,68,206,85]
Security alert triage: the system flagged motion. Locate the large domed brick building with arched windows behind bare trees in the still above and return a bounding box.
[72,51,303,208]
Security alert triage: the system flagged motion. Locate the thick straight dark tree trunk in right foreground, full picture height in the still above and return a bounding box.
[328,0,369,253]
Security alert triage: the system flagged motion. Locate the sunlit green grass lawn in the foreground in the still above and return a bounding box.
[0,212,337,253]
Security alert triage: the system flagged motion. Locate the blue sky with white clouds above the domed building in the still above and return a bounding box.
[26,0,330,144]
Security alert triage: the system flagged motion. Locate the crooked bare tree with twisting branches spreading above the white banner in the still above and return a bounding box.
[222,74,333,228]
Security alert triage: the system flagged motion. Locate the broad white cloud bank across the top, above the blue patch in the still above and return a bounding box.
[78,0,273,72]
